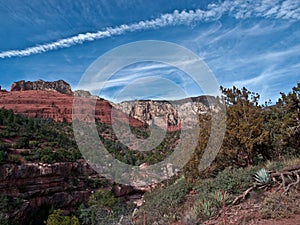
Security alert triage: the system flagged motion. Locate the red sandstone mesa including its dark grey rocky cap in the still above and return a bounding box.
[0,80,144,126]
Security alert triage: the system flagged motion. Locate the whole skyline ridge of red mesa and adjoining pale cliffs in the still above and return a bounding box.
[0,80,216,131]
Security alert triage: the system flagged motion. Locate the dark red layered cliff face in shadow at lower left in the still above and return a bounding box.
[0,160,108,224]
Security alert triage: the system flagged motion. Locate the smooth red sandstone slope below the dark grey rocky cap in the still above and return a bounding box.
[0,90,144,126]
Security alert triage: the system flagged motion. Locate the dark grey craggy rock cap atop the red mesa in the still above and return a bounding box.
[10,80,73,95]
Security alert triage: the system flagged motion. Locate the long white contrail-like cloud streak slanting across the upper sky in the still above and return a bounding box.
[0,0,300,58]
